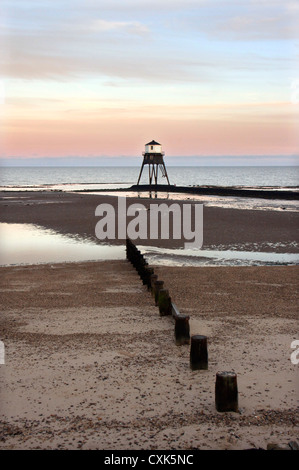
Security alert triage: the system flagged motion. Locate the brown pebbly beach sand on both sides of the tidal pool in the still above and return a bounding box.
[0,192,299,450]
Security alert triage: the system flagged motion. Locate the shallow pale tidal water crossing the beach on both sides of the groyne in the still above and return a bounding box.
[0,223,299,266]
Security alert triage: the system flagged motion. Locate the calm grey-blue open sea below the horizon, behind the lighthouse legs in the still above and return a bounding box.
[0,163,299,191]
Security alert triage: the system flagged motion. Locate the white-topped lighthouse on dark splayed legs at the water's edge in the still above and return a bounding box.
[137,140,170,186]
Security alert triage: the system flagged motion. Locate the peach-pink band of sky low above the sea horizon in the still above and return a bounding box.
[4,104,299,157]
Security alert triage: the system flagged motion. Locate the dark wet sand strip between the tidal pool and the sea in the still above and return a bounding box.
[0,191,299,253]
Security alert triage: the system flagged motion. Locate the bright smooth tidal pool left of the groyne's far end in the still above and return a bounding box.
[0,224,125,266]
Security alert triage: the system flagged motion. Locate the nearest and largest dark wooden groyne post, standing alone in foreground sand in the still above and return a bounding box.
[215,372,238,411]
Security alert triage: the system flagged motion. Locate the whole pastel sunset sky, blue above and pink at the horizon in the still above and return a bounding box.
[0,0,299,165]
